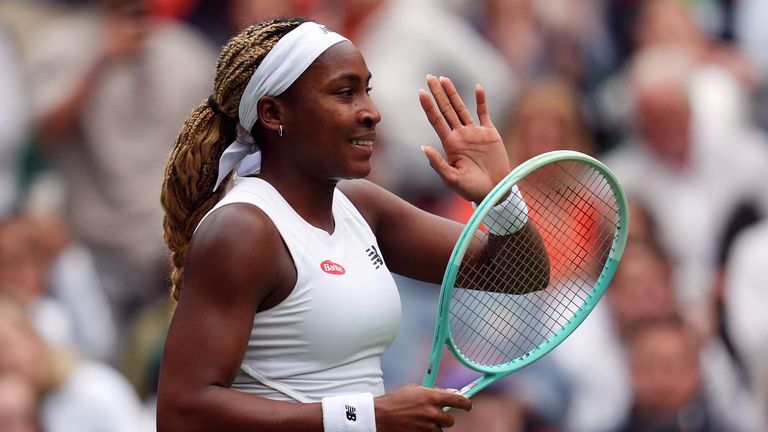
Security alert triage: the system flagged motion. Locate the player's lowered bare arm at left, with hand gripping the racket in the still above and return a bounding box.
[157,204,471,432]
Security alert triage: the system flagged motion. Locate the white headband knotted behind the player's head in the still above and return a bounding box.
[213,21,349,191]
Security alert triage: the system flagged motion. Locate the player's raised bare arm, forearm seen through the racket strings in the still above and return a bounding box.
[339,180,549,293]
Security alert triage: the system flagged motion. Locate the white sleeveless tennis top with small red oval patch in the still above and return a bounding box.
[195,177,401,402]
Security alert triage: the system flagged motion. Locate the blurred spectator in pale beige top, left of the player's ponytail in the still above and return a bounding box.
[30,0,215,331]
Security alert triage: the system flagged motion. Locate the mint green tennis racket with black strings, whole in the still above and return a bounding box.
[423,150,629,397]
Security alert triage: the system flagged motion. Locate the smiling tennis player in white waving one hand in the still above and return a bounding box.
[158,19,546,432]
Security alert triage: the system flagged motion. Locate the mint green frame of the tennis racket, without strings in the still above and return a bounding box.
[422,150,629,397]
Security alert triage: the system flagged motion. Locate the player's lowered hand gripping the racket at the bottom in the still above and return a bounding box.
[374,384,472,432]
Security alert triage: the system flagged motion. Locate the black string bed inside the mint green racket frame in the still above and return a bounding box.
[449,162,619,365]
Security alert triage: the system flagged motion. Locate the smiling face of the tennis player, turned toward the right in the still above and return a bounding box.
[278,42,381,180]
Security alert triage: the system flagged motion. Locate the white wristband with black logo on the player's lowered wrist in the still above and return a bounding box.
[322,393,376,432]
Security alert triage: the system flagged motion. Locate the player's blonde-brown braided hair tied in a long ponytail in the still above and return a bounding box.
[160,18,304,300]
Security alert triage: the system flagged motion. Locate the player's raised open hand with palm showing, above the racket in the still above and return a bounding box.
[419,75,510,203]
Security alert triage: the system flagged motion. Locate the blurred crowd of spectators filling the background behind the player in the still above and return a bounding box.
[0,0,768,432]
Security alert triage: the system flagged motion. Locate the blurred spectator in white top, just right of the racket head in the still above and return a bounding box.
[605,50,768,331]
